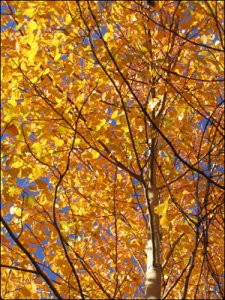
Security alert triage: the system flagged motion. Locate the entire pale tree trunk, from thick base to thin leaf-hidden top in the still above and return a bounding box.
[144,5,169,299]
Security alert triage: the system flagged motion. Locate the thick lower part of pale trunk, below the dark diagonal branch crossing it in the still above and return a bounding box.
[145,139,161,299]
